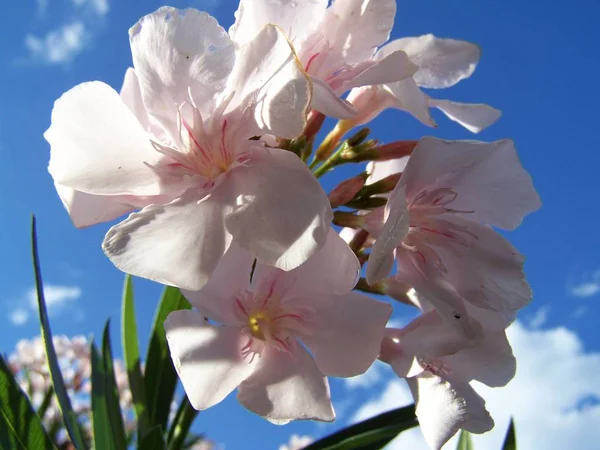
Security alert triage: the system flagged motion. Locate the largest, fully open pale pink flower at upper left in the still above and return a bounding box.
[45,7,332,289]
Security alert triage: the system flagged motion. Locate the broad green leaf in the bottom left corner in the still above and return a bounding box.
[0,355,56,450]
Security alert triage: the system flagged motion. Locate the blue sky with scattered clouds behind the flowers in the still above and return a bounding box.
[0,0,600,449]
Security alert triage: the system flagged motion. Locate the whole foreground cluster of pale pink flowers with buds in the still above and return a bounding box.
[45,0,540,448]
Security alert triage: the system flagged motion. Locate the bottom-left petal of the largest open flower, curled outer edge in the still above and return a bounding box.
[102,188,231,290]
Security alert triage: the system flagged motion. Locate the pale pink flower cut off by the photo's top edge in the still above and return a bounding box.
[229,0,417,119]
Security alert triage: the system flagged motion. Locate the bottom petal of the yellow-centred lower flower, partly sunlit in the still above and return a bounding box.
[237,345,335,424]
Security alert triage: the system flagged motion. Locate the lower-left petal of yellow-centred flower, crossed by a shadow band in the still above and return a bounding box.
[165,310,258,411]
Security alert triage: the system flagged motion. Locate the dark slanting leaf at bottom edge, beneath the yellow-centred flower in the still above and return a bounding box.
[304,405,419,450]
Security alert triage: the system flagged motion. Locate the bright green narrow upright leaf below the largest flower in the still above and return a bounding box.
[121,275,150,436]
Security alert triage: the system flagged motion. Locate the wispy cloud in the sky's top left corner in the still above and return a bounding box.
[24,0,110,65]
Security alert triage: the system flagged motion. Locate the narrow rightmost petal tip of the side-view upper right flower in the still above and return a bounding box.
[429,98,502,133]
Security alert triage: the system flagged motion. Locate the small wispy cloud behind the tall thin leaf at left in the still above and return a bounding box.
[8,284,81,326]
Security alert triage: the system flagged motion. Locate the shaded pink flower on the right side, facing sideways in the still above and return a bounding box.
[367,137,540,334]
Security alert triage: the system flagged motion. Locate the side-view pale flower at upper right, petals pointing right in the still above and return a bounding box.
[347,34,500,133]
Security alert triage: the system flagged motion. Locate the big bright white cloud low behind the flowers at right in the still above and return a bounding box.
[346,322,600,450]
